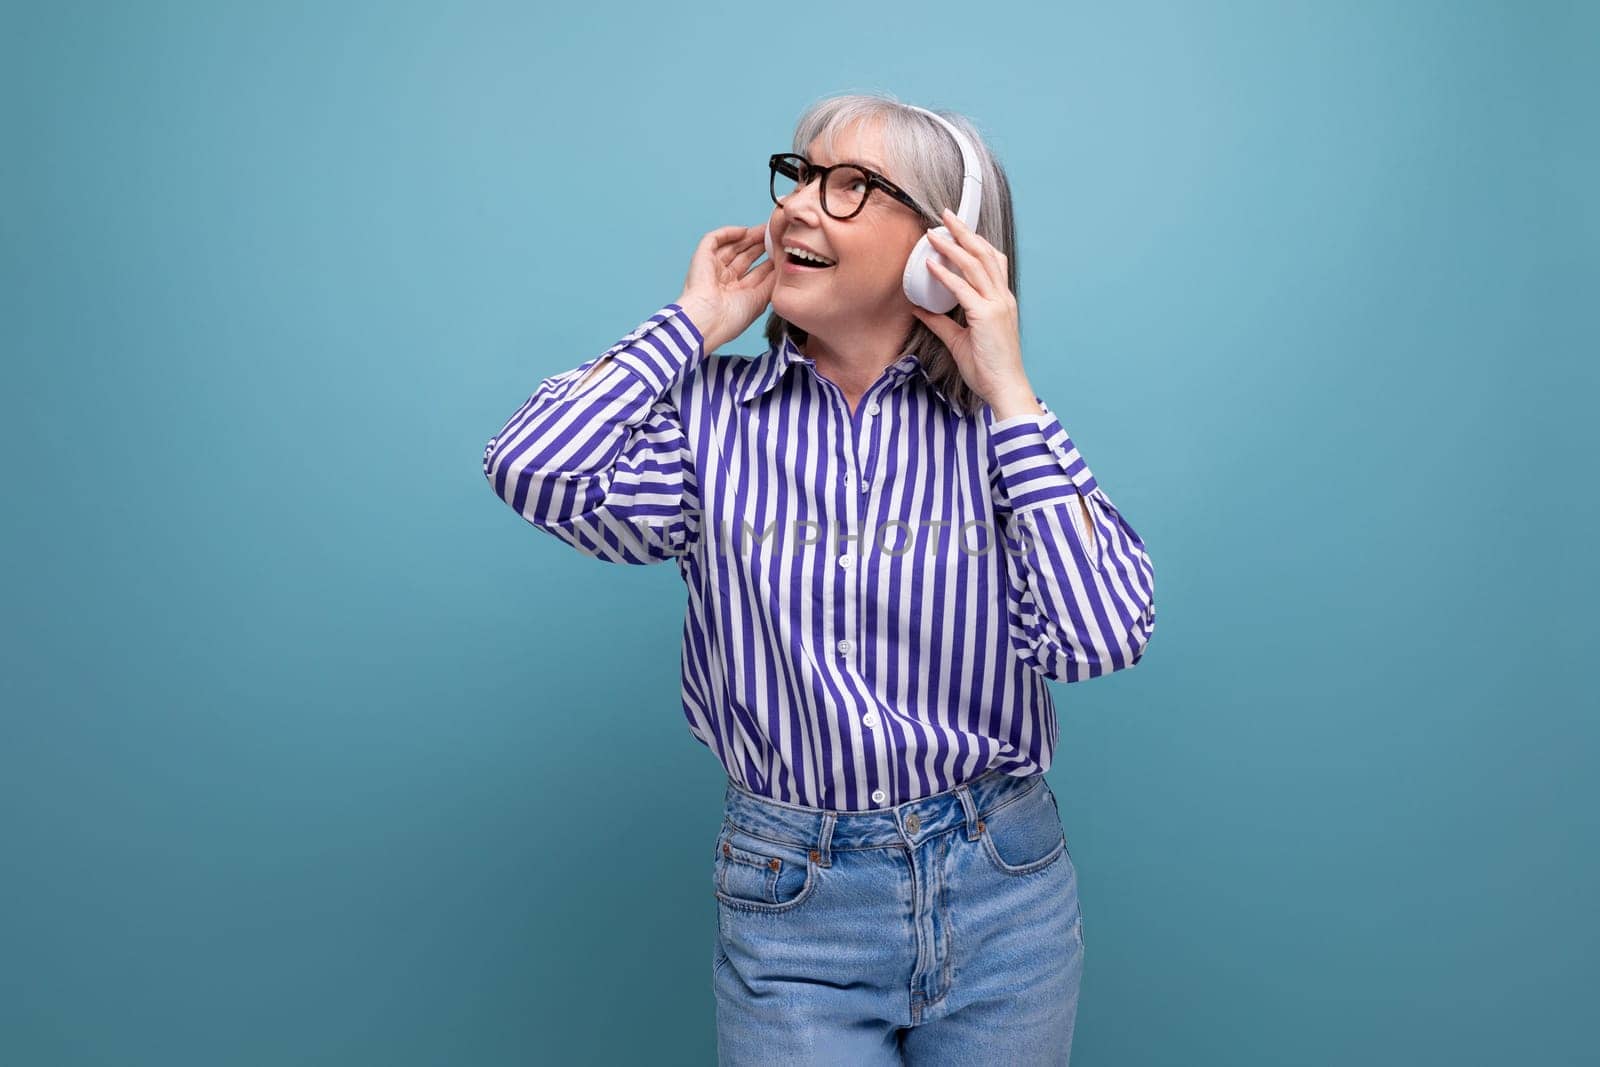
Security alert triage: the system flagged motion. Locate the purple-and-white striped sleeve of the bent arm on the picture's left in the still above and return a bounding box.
[483,304,706,565]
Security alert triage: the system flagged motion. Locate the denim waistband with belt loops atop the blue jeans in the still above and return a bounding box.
[723,769,1045,862]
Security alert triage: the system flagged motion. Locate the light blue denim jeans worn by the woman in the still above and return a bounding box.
[712,771,1083,1067]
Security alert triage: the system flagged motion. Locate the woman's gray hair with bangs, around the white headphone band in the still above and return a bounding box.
[766,93,1021,414]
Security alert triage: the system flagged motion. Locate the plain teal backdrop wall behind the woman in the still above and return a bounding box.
[0,2,1600,1067]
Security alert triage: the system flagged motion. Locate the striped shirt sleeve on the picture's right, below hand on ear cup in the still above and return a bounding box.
[989,397,1155,681]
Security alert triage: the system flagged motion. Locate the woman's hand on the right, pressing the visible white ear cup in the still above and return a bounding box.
[910,208,1035,406]
